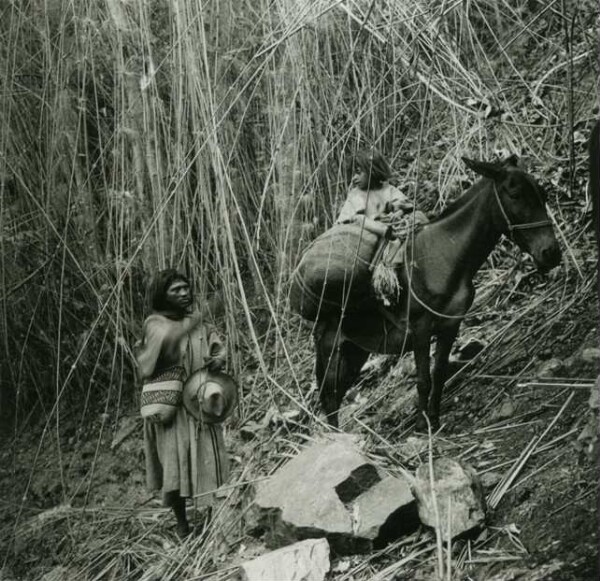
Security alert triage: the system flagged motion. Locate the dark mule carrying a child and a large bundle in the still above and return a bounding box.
[314,157,561,431]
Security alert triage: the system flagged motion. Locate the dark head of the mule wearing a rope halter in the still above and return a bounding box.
[463,156,560,272]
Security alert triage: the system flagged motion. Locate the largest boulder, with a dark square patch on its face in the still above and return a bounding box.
[249,434,416,555]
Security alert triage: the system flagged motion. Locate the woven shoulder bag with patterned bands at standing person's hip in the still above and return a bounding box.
[140,366,185,424]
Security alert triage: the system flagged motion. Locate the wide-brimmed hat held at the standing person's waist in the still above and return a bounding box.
[183,369,237,424]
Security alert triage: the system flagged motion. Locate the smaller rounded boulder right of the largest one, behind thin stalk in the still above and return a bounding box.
[413,457,485,539]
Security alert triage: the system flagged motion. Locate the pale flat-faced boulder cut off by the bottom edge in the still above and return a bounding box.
[237,539,331,581]
